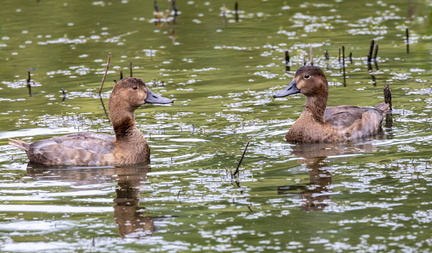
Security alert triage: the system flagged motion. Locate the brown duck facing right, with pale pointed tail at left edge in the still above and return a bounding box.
[9,77,173,166]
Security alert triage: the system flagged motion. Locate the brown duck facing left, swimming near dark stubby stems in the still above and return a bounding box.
[273,65,391,143]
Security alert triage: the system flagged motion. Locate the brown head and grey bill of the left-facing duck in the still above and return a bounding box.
[273,66,328,98]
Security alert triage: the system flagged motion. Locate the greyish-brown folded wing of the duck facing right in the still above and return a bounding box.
[27,133,115,165]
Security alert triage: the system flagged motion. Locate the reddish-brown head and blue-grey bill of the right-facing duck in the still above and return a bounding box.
[109,77,173,111]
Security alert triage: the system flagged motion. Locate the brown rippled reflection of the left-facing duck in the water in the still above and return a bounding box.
[277,143,375,212]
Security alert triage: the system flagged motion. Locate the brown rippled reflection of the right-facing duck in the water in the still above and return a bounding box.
[27,163,173,238]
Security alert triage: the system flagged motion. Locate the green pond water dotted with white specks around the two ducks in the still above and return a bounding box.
[0,0,432,252]
